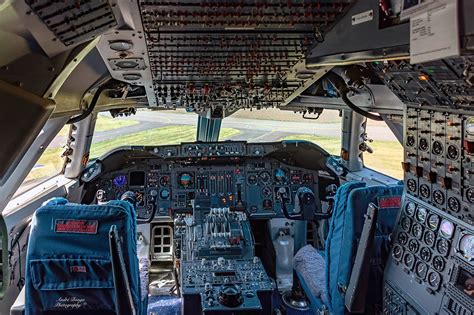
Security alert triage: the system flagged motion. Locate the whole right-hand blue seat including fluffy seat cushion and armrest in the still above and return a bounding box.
[294,182,403,314]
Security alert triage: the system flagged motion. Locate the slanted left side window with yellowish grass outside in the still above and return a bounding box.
[15,125,70,195]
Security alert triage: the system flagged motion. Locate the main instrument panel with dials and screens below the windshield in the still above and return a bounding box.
[85,142,336,219]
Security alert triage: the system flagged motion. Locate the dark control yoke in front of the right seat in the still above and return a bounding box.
[277,187,332,221]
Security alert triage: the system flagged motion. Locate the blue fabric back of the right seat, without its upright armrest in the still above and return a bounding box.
[325,182,403,314]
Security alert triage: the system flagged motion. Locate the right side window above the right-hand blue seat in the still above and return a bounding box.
[364,120,403,179]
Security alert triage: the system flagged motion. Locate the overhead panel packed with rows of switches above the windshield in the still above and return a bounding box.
[140,0,351,110]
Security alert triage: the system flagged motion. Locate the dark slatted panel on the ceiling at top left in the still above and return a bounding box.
[25,0,117,46]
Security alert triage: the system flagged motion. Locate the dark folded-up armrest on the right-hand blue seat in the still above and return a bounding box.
[344,203,379,313]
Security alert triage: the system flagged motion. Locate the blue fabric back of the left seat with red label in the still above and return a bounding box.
[25,198,146,315]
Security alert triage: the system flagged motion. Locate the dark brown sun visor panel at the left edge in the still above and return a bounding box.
[0,80,56,185]
